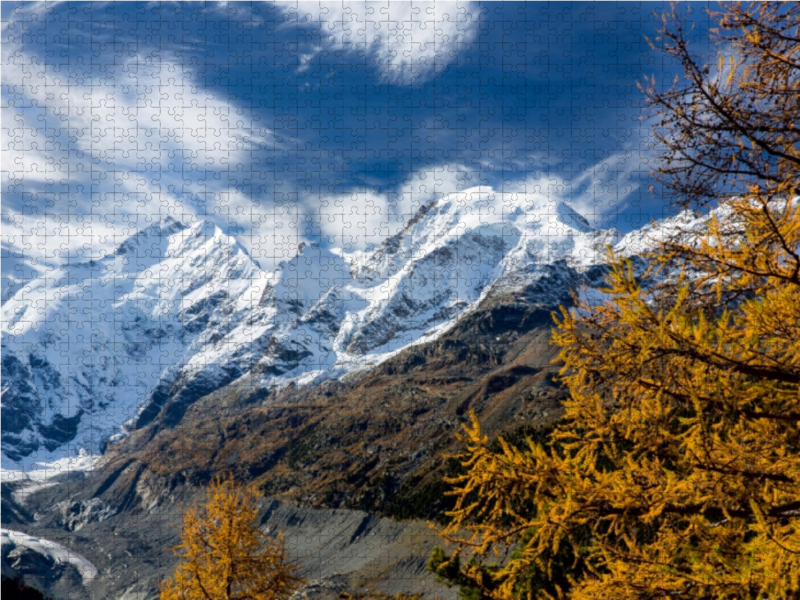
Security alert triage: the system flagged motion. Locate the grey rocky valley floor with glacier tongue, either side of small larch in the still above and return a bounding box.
[2,472,455,600]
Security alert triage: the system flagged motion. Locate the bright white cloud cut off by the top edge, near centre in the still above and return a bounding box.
[276,0,480,85]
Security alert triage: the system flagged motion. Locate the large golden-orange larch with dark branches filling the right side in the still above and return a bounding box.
[431,3,800,600]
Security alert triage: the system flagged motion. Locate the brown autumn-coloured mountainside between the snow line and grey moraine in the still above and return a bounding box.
[106,296,564,518]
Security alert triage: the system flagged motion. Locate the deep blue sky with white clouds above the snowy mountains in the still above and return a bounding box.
[2,2,706,268]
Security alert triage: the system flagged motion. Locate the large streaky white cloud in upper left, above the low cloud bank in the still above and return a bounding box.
[2,51,271,173]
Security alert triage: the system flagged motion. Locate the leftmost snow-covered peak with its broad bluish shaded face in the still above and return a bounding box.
[2,219,262,468]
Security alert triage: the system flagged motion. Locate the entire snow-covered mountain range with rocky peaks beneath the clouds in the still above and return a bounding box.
[2,188,700,467]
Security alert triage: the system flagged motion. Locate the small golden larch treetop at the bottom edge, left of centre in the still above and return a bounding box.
[161,478,302,600]
